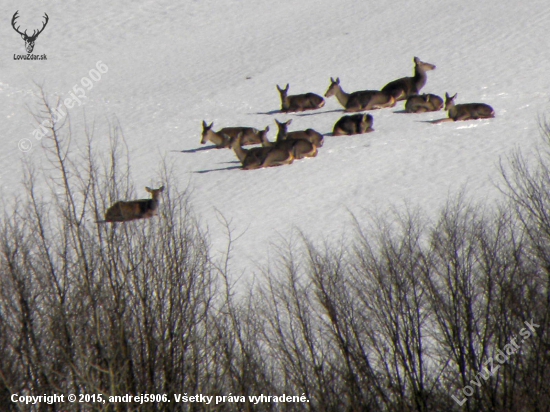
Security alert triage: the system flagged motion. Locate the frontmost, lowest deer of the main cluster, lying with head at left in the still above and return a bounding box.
[232,133,294,170]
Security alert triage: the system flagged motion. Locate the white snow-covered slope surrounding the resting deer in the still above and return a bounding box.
[0,0,550,273]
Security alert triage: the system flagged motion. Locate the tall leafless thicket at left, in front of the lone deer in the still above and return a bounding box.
[0,91,217,409]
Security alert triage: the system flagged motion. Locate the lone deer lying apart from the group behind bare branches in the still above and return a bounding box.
[97,186,164,223]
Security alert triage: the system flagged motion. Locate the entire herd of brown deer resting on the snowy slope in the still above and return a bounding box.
[100,57,495,222]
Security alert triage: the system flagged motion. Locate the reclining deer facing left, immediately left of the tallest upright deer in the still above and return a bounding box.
[325,77,395,112]
